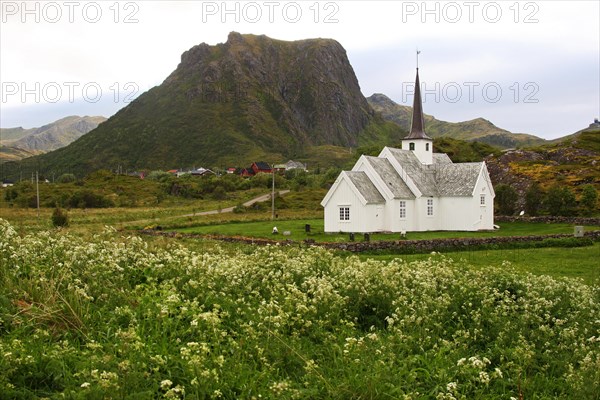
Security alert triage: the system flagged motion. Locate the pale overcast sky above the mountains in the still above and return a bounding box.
[0,0,600,139]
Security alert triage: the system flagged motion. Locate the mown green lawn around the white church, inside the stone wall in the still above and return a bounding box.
[178,219,600,242]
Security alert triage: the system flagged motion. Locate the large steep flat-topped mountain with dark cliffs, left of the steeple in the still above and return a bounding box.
[6,32,406,173]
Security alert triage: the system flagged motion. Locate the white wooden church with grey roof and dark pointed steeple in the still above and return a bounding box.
[321,68,495,233]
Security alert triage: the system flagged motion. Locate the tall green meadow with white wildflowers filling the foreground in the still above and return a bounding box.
[0,220,600,399]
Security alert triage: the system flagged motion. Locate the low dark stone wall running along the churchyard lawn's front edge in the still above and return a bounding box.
[140,229,600,254]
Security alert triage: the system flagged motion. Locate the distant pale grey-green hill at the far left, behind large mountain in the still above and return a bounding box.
[0,116,106,162]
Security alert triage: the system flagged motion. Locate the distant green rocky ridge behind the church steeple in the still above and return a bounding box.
[367,93,547,149]
